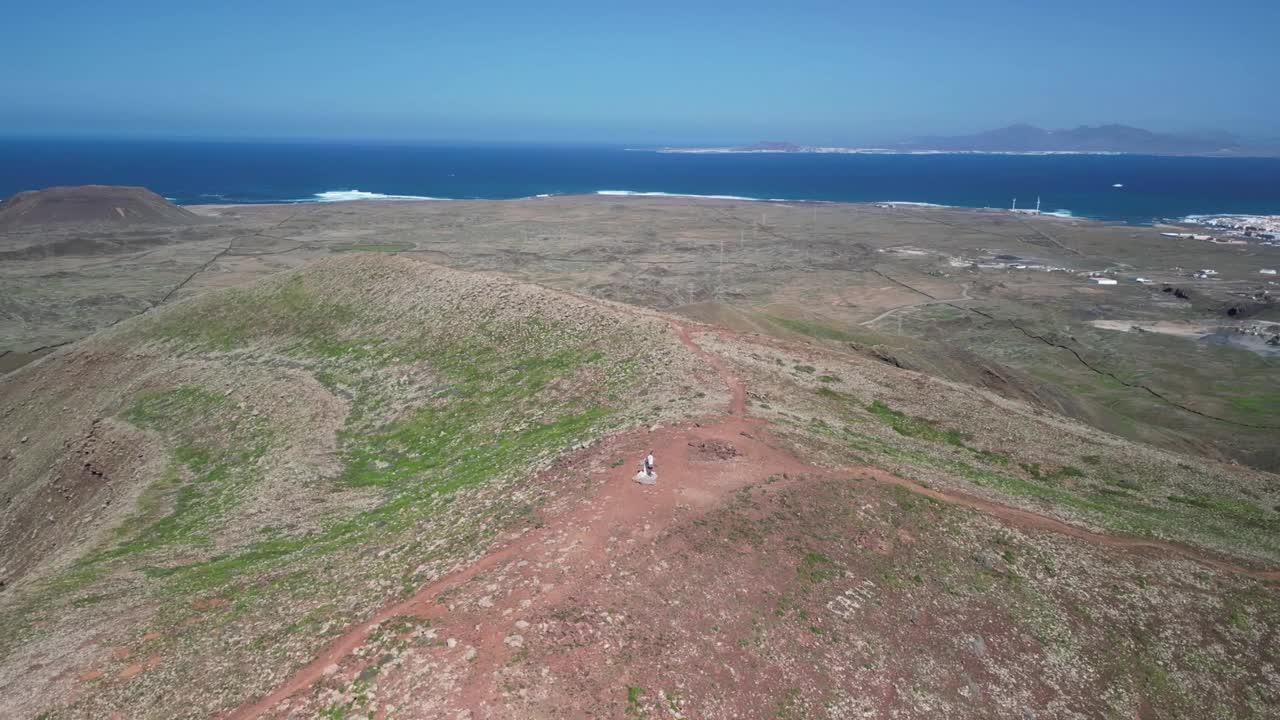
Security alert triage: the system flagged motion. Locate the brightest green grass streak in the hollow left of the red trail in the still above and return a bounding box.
[153,340,628,592]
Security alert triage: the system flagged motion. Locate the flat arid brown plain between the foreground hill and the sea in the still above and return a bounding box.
[0,196,1280,469]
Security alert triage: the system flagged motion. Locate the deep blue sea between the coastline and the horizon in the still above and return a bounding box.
[0,140,1280,223]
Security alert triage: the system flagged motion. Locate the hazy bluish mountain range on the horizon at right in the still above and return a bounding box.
[899,124,1277,155]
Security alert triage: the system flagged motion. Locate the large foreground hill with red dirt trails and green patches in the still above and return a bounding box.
[0,255,1280,717]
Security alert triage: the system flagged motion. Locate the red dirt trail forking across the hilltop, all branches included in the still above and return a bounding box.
[225,322,1280,720]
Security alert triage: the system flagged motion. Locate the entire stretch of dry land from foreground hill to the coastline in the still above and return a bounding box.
[0,188,1280,720]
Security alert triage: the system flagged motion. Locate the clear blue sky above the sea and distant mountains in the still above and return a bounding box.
[0,0,1280,143]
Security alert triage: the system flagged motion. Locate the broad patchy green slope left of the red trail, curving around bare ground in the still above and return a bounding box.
[0,267,650,691]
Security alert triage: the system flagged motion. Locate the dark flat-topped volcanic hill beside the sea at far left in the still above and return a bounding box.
[0,184,202,232]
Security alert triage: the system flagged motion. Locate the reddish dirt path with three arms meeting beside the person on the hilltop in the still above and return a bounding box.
[227,322,1280,720]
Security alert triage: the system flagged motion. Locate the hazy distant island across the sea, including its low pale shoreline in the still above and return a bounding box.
[658,124,1280,158]
